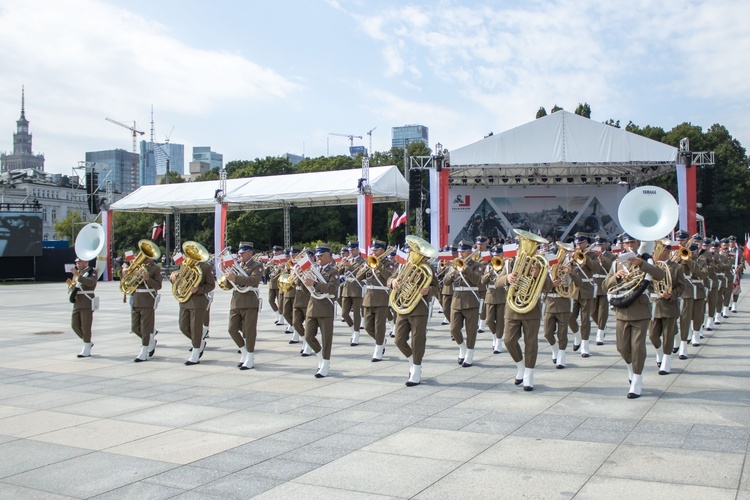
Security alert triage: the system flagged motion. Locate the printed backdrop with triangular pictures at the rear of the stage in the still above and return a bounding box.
[449,185,627,243]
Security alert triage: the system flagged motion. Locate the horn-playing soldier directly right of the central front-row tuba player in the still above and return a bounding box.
[443,241,482,368]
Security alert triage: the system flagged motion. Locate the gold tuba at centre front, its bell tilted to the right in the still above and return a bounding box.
[388,235,437,314]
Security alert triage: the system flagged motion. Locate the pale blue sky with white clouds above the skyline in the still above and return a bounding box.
[0,0,750,174]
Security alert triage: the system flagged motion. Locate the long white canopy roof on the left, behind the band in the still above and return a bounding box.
[110,165,409,213]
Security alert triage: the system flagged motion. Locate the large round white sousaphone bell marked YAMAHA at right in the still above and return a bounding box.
[617,186,680,254]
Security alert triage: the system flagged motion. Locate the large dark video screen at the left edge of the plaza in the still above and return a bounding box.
[0,212,43,257]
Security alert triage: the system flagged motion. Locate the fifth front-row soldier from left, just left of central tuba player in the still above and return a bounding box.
[304,245,339,378]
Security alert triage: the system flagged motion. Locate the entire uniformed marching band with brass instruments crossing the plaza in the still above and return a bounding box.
[67,204,745,399]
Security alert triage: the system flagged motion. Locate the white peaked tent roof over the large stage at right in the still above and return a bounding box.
[450,111,678,185]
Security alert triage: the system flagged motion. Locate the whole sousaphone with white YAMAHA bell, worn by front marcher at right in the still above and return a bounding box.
[607,186,679,308]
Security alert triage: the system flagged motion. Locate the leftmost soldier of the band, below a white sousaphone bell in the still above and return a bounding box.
[65,257,99,358]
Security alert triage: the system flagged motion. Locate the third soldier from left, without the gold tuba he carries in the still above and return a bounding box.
[169,254,216,366]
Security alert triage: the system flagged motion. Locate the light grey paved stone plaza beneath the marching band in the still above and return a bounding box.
[0,283,750,500]
